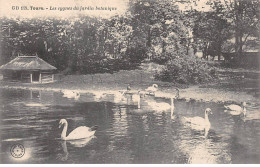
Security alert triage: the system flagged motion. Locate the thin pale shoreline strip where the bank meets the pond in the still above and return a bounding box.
[0,86,254,104]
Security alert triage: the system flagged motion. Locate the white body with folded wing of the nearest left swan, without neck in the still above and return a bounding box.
[66,126,95,140]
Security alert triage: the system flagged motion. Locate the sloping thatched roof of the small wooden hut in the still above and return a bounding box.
[0,56,57,70]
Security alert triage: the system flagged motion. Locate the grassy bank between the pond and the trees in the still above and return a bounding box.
[0,64,260,104]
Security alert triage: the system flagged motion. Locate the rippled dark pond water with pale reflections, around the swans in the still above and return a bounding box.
[0,89,260,164]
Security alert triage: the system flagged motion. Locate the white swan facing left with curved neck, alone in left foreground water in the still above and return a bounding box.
[59,119,97,140]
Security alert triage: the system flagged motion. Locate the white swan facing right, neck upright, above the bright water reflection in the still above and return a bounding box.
[183,108,212,137]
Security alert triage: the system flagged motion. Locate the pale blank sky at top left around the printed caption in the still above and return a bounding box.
[0,0,128,18]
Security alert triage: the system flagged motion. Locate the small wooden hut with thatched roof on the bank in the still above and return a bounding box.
[0,56,57,83]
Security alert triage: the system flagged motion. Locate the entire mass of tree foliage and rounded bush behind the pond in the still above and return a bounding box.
[0,0,259,83]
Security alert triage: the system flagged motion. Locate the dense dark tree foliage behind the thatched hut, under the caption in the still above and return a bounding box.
[1,16,143,73]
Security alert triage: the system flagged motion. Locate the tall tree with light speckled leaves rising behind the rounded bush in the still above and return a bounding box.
[130,0,188,63]
